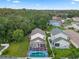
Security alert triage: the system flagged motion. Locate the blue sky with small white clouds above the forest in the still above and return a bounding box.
[0,0,79,10]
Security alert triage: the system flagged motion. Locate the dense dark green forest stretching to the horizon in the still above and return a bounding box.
[0,8,79,42]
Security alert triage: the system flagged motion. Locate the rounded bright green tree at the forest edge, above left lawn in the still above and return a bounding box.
[12,29,24,42]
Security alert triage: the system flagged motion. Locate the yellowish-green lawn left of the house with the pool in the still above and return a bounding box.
[3,40,29,57]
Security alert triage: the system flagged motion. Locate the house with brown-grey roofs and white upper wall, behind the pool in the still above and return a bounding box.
[30,28,45,48]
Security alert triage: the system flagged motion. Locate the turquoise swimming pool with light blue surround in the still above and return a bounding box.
[28,51,48,57]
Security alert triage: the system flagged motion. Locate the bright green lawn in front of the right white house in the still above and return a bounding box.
[53,48,79,59]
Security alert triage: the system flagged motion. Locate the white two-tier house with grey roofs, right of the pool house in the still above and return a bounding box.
[50,28,70,48]
